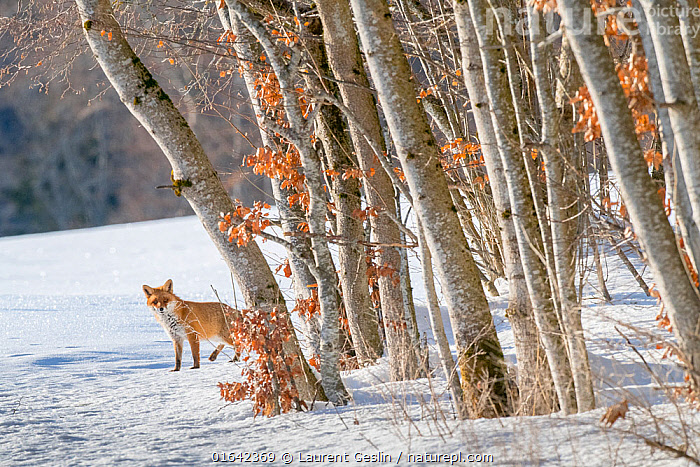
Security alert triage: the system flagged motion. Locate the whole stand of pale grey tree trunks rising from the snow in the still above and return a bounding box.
[50,0,700,418]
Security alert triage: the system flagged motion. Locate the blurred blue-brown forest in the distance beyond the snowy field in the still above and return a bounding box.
[0,0,270,236]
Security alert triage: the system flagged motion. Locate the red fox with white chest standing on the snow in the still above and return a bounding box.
[143,279,240,371]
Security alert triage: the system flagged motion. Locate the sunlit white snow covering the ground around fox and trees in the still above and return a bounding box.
[0,218,700,466]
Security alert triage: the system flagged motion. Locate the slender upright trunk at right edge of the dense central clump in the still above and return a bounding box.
[528,6,595,412]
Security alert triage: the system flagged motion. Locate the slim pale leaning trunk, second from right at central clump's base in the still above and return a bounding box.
[462,0,576,414]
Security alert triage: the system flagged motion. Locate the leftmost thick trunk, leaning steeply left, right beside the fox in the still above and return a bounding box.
[76,0,316,399]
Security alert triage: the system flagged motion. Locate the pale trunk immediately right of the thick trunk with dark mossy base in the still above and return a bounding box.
[452,1,557,415]
